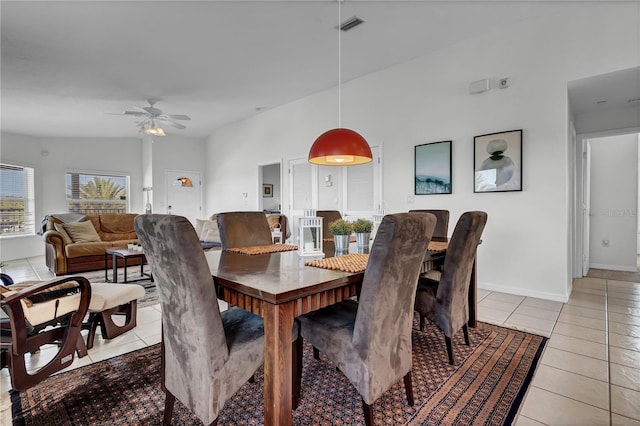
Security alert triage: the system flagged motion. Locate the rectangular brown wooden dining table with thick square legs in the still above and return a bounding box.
[205,243,475,426]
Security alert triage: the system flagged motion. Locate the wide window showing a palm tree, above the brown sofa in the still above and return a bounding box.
[66,172,129,214]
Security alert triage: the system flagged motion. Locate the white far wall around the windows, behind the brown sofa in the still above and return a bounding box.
[0,133,204,260]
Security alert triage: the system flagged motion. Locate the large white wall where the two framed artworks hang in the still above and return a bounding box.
[206,3,640,301]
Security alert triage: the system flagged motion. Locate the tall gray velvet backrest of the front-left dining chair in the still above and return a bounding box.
[134,214,229,422]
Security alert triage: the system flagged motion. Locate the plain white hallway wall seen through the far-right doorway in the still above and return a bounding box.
[589,134,638,272]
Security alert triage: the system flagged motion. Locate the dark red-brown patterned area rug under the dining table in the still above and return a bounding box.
[11,321,547,426]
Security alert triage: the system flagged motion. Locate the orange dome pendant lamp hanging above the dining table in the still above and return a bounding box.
[309,0,373,166]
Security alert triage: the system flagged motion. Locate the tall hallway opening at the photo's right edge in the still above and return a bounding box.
[567,66,640,278]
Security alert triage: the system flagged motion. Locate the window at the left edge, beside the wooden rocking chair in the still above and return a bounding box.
[0,163,35,237]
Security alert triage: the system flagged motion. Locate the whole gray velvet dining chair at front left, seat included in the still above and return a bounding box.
[135,214,264,425]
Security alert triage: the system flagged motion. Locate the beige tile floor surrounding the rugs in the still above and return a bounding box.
[0,257,640,426]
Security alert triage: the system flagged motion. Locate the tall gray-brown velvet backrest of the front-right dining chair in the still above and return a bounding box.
[353,213,436,378]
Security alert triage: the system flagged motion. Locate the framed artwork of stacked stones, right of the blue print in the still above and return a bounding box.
[473,130,522,192]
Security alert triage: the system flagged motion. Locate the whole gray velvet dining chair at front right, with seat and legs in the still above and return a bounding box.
[293,213,436,425]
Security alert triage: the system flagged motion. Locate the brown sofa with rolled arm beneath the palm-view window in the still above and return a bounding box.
[43,213,139,275]
